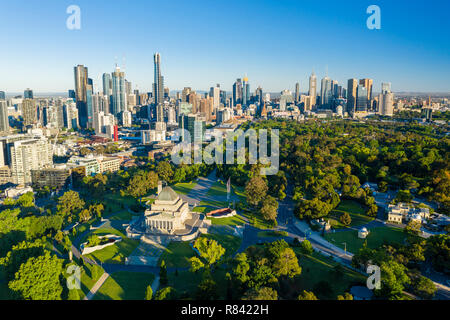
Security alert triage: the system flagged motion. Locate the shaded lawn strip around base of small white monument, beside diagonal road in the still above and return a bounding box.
[324,227,414,253]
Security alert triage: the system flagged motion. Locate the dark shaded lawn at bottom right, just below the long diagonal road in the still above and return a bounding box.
[288,247,366,300]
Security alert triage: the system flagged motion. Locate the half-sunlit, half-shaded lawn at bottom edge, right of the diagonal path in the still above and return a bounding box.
[94,271,155,300]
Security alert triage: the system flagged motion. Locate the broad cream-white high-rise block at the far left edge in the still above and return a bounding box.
[0,135,53,185]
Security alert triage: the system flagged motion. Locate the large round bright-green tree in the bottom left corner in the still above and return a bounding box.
[8,252,63,300]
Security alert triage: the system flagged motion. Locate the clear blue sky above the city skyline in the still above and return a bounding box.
[0,0,450,92]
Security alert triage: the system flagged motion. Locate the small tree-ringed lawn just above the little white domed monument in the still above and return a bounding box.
[329,200,375,229]
